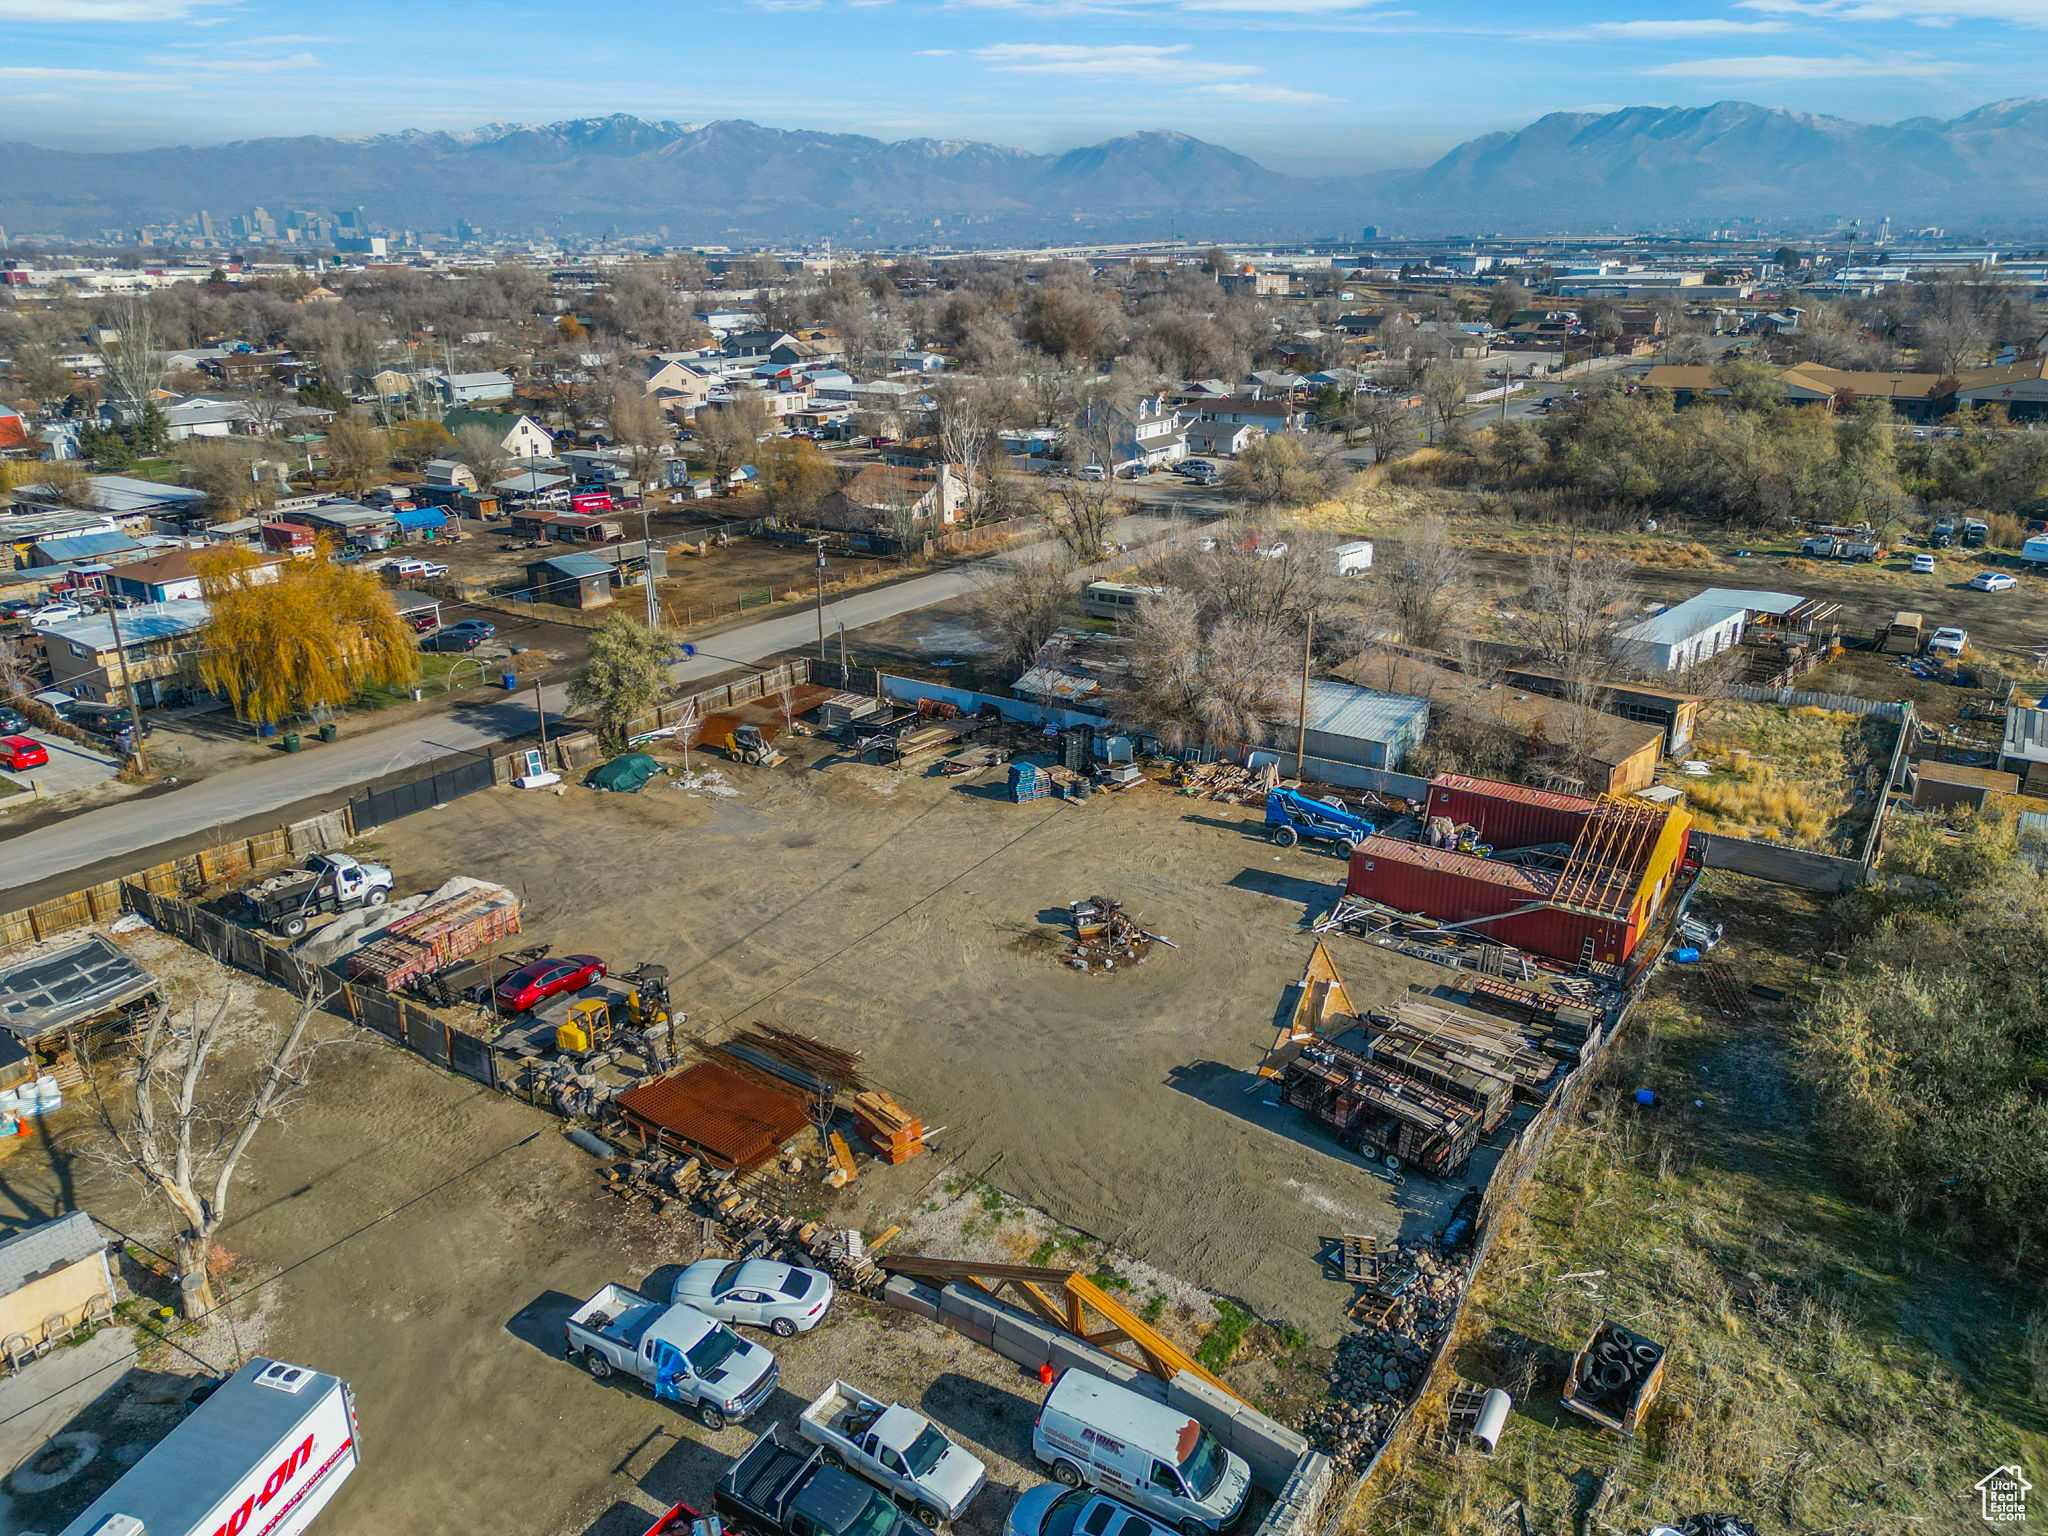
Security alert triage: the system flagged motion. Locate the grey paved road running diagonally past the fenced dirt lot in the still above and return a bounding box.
[0,505,1182,893]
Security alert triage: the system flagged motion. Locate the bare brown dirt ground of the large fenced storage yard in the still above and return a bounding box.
[360,741,1483,1339]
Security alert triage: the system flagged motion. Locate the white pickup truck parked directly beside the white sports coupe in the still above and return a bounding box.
[565,1286,780,1432]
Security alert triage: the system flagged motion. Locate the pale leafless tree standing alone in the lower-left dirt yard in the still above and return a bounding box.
[88,975,324,1319]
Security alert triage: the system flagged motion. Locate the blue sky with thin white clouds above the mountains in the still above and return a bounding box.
[0,0,2048,172]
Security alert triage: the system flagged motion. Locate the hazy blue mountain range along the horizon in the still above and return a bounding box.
[0,96,2048,244]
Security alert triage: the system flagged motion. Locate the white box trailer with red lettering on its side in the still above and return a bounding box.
[59,1360,358,1536]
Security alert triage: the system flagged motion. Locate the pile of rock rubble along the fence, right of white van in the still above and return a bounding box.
[1307,1239,1466,1473]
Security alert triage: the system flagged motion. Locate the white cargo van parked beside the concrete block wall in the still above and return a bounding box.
[1030,1370,1251,1536]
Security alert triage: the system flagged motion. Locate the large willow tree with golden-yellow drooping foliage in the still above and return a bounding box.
[193,545,420,725]
